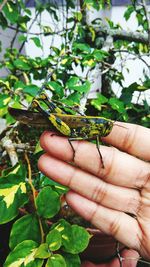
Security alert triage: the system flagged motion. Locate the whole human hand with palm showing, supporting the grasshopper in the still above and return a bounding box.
[38,122,150,267]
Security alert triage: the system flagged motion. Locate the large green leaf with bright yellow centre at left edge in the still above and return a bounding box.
[0,165,28,224]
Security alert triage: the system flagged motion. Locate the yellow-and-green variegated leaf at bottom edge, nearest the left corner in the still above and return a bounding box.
[4,240,43,267]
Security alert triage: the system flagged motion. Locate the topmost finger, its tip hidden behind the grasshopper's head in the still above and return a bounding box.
[103,122,150,160]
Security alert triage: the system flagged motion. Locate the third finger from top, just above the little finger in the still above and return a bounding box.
[38,154,140,215]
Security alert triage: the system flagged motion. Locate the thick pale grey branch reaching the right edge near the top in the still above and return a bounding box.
[92,25,149,45]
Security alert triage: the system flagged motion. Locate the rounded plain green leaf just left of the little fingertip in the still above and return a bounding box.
[36,186,60,218]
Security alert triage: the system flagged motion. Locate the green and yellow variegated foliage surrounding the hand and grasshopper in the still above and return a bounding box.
[0,0,150,267]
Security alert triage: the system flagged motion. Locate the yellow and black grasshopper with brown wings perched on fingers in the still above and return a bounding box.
[9,94,114,168]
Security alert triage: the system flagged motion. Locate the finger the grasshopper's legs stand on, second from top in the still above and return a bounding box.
[40,132,150,188]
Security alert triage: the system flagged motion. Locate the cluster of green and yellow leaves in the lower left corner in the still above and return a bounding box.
[0,164,90,267]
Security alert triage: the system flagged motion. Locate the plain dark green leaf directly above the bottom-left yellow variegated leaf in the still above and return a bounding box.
[9,214,41,249]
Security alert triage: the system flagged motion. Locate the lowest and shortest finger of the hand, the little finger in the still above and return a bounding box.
[66,191,142,255]
